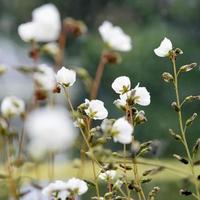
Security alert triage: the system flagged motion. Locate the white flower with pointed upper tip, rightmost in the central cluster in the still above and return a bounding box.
[134,83,151,106]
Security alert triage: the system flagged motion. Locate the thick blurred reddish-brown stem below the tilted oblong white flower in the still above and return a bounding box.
[90,55,107,99]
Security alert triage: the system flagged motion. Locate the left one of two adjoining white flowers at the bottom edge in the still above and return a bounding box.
[42,181,69,200]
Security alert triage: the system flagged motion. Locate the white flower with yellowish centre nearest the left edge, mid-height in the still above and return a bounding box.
[1,96,25,118]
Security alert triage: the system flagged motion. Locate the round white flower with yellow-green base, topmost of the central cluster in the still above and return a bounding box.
[112,76,131,94]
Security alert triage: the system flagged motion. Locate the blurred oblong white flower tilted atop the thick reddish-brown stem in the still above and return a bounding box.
[99,21,132,51]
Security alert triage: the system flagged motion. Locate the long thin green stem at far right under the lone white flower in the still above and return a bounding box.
[171,55,200,200]
